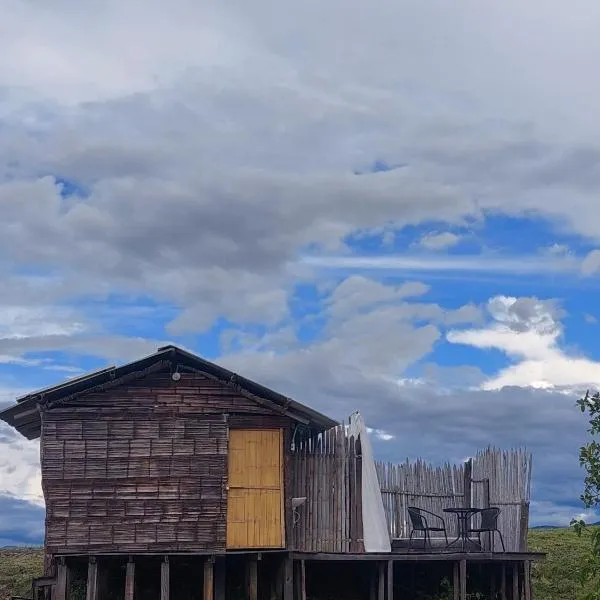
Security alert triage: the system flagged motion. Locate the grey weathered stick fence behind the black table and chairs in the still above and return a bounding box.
[376,448,531,552]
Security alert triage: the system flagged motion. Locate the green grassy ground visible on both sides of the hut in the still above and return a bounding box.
[0,529,590,600]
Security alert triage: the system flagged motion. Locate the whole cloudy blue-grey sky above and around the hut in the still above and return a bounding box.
[0,0,600,545]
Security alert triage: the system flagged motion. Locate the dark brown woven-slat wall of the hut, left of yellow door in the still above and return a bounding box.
[41,373,282,554]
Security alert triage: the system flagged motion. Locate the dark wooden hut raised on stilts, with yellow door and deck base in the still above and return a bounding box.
[0,346,535,600]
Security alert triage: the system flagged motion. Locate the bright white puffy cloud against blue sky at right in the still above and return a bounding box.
[447,296,600,390]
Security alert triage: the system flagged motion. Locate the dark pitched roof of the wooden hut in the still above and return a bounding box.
[0,345,338,440]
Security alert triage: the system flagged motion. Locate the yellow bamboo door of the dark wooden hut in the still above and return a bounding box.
[227,429,284,549]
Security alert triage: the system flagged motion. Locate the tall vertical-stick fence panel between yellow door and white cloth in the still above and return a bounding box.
[292,425,364,552]
